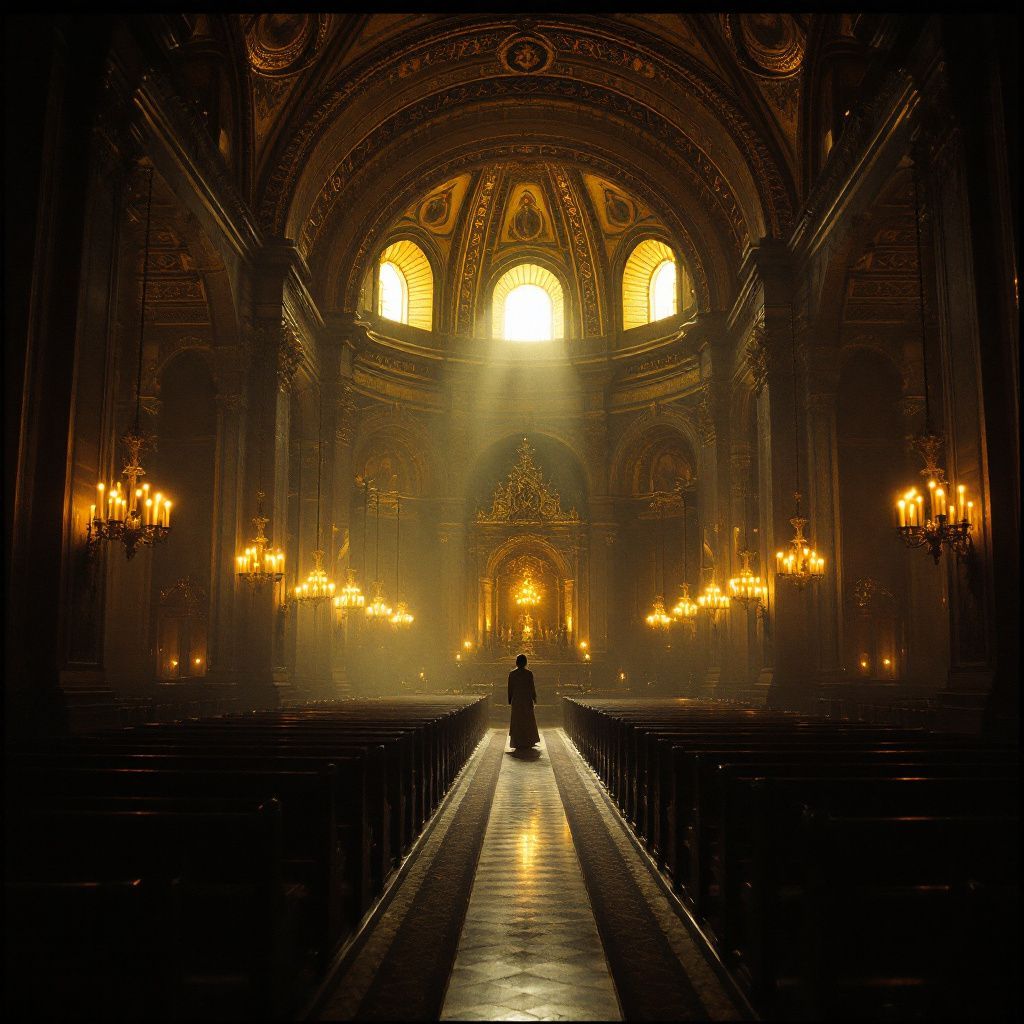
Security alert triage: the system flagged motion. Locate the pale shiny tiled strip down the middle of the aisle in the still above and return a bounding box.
[441,730,622,1020]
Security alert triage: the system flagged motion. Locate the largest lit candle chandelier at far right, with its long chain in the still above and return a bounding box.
[896,163,974,565]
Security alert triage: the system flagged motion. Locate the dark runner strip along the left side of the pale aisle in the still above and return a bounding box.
[354,730,505,1021]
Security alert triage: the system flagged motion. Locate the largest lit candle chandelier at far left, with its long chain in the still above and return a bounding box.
[86,167,171,559]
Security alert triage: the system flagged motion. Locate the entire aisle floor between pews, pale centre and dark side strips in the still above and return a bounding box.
[311,727,744,1020]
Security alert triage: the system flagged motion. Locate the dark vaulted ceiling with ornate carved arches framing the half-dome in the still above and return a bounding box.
[176,12,880,309]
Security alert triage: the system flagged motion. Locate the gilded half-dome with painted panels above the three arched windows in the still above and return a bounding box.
[360,161,686,337]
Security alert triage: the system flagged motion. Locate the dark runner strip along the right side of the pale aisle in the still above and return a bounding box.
[544,729,717,1021]
